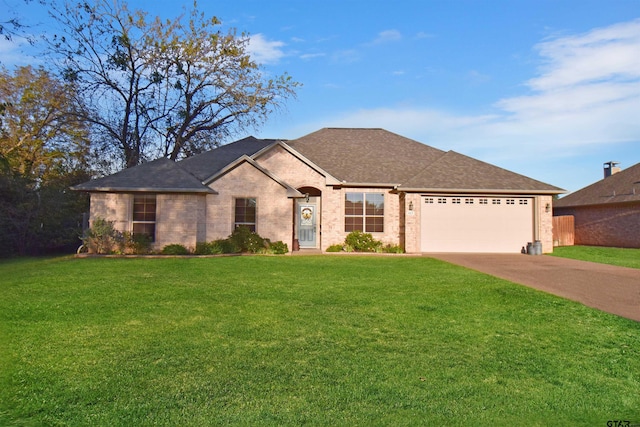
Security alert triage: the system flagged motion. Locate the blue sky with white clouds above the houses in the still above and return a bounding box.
[0,0,640,191]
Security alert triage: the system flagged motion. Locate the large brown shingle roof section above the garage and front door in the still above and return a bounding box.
[287,128,564,194]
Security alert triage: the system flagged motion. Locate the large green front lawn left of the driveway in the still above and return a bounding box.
[0,256,640,426]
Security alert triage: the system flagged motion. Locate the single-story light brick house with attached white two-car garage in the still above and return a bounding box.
[73,128,564,253]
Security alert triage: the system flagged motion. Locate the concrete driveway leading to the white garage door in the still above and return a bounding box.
[425,253,640,322]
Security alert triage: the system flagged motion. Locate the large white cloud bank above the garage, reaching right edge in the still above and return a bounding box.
[302,20,640,162]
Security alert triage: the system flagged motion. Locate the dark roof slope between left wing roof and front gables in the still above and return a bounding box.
[178,136,276,181]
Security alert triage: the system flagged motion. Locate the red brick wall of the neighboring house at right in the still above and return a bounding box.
[554,203,640,248]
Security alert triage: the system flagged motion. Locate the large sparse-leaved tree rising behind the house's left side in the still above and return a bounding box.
[50,0,298,167]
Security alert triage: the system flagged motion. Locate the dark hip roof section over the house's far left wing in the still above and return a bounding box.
[71,157,216,194]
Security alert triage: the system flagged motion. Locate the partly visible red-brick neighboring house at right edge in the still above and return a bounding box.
[553,162,640,248]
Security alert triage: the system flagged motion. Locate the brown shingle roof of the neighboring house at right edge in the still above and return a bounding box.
[553,163,640,208]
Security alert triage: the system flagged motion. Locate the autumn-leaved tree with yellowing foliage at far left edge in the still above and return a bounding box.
[0,67,89,255]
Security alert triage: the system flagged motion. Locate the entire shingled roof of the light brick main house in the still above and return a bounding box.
[72,128,564,197]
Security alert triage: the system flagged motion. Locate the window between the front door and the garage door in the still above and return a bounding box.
[344,193,384,233]
